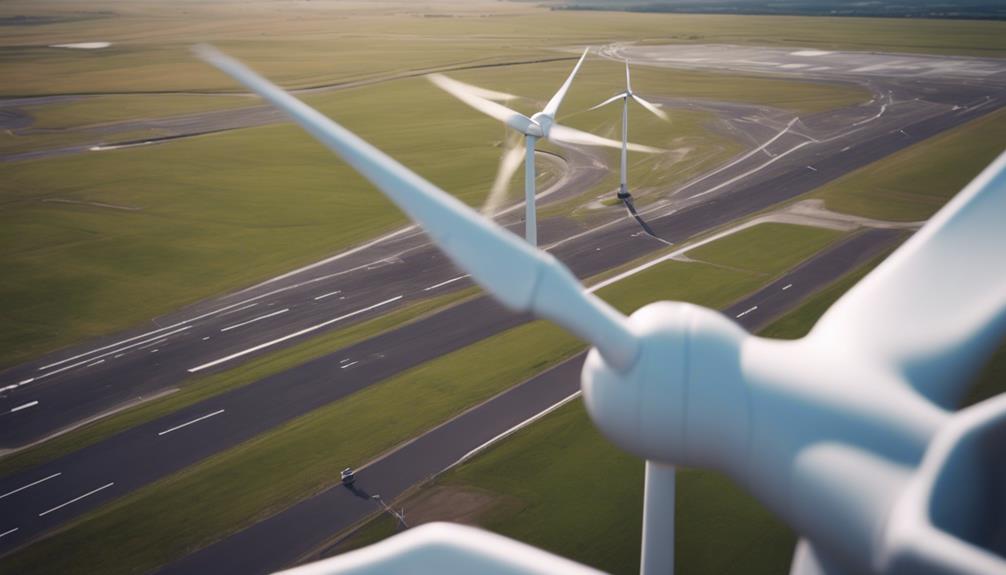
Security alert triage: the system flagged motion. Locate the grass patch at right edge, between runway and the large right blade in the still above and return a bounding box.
[813,111,1006,221]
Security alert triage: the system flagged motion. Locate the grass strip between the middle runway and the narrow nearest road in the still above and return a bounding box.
[5,222,832,573]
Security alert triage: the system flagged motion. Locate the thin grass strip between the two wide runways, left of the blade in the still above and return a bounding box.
[0,289,476,475]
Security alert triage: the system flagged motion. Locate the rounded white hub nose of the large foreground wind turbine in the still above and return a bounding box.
[580,302,749,470]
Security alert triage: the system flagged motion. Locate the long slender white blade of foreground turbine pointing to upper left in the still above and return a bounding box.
[197,46,640,370]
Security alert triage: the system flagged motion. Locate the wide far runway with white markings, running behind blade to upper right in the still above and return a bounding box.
[0,47,1006,448]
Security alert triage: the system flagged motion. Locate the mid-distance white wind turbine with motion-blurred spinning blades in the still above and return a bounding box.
[430,47,660,245]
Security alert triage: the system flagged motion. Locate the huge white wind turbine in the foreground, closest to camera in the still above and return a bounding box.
[200,48,1006,574]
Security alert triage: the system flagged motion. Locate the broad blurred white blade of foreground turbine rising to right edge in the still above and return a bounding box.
[809,153,1006,407]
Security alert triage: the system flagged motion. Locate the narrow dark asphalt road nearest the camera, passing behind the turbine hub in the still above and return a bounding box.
[158,229,904,575]
